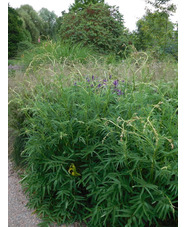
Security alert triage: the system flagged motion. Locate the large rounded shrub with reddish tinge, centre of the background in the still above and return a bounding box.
[60,3,129,54]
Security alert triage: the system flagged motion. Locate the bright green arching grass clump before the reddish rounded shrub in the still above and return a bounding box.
[15,40,95,71]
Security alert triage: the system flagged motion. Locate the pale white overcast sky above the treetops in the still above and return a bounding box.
[8,0,178,31]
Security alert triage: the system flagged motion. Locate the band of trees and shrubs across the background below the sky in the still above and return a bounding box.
[9,0,178,59]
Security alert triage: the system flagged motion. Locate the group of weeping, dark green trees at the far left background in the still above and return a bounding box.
[8,5,57,57]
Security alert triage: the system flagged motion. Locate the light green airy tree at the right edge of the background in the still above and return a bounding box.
[131,0,178,59]
